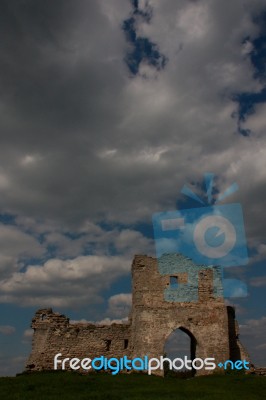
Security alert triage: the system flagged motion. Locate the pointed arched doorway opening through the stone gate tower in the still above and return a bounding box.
[164,327,197,377]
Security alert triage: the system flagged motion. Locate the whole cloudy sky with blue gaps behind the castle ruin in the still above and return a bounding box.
[0,0,266,376]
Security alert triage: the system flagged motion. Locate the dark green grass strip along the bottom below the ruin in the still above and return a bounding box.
[0,371,266,400]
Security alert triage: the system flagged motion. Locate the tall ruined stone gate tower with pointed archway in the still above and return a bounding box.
[132,256,244,374]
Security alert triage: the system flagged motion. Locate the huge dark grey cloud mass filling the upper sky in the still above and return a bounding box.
[0,0,262,234]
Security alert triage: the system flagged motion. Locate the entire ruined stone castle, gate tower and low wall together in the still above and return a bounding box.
[26,255,249,375]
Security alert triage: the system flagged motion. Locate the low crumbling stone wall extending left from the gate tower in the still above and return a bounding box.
[26,309,131,371]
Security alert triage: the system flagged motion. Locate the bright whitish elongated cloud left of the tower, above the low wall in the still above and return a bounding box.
[0,256,131,307]
